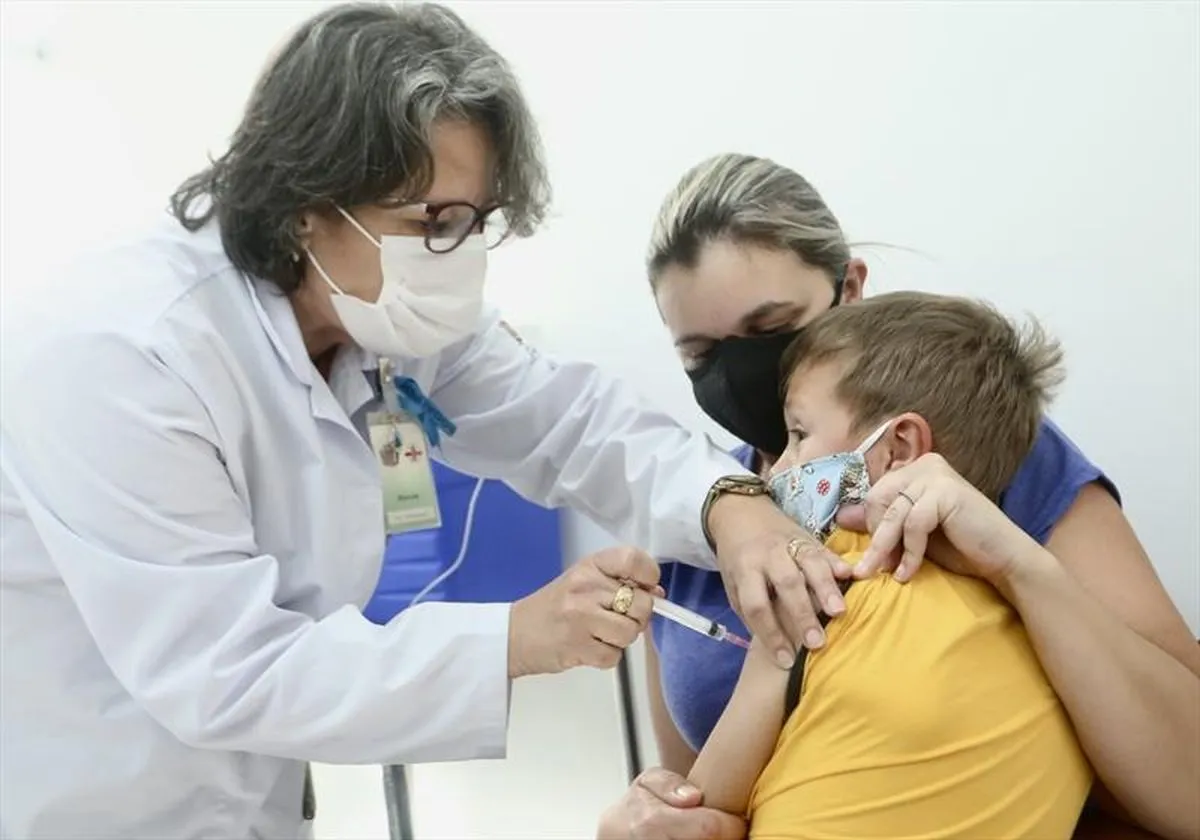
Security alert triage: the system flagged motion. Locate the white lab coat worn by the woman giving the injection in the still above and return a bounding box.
[0,221,742,840]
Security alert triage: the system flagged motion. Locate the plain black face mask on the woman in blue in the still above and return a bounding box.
[688,277,842,457]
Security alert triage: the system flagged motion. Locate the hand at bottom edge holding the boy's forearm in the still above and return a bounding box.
[596,767,746,840]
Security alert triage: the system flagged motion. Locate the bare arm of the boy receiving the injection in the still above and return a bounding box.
[688,642,787,815]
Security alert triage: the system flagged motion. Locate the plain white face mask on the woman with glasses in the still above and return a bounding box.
[305,208,487,358]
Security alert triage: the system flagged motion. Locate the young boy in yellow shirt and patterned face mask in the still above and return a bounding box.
[689,293,1092,840]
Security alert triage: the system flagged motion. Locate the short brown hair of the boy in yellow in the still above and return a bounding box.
[784,292,1063,499]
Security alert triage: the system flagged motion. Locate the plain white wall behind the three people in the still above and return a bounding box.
[0,0,1200,643]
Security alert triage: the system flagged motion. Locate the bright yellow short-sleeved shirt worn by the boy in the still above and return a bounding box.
[750,532,1092,840]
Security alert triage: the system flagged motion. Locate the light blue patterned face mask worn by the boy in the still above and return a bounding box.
[767,420,892,541]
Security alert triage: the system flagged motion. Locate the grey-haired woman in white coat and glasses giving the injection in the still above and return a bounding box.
[0,6,832,840]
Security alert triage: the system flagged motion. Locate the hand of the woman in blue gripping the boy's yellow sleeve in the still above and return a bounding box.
[838,454,1036,584]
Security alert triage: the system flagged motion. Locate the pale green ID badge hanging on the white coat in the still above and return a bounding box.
[367,412,442,534]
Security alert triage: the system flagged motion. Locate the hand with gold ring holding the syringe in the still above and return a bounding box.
[509,548,662,678]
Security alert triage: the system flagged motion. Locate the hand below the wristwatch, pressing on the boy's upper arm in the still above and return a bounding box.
[708,493,851,668]
